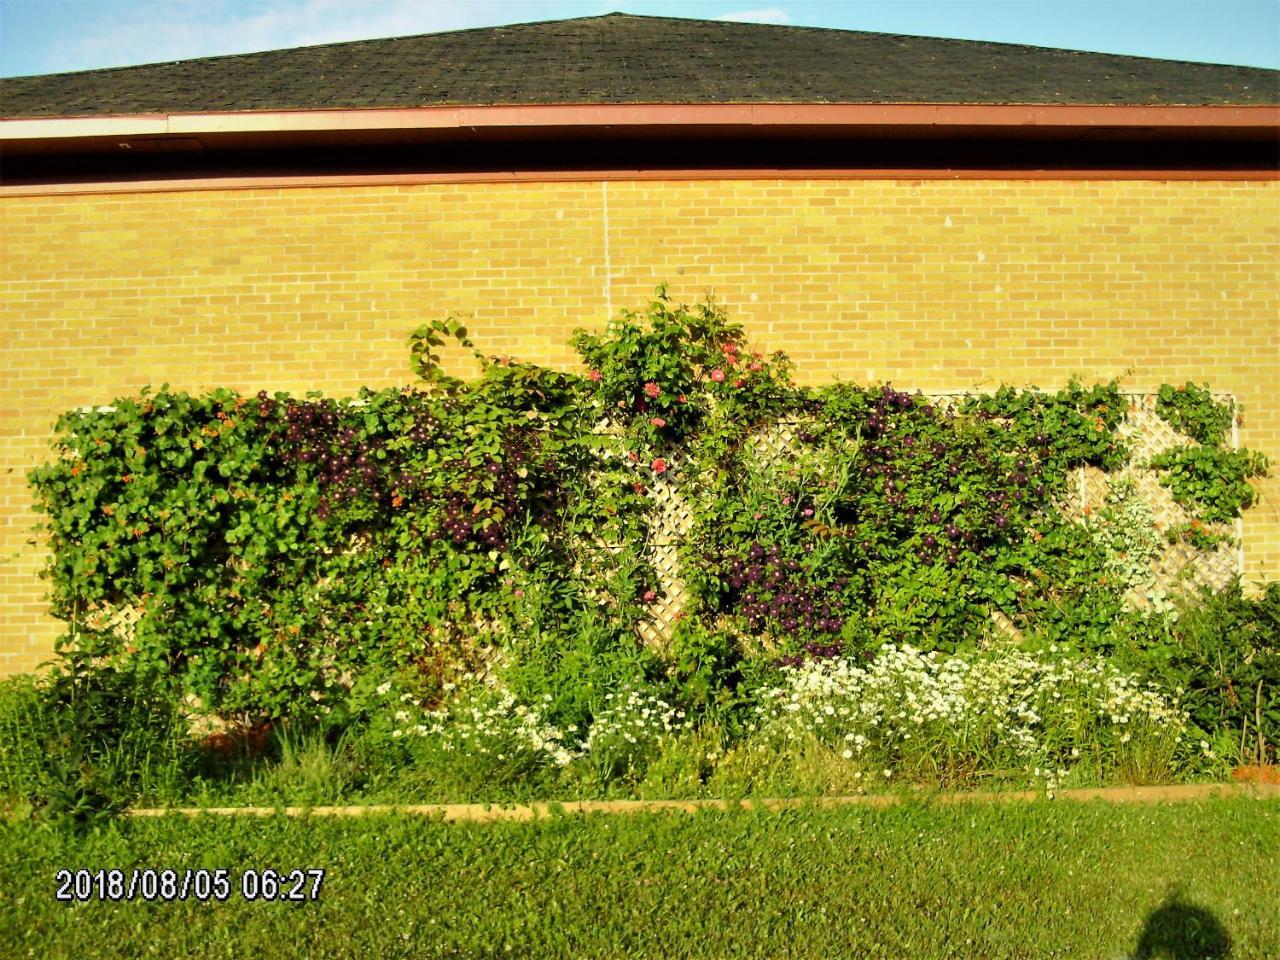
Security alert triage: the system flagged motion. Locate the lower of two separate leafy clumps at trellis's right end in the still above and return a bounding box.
[1151,447,1267,524]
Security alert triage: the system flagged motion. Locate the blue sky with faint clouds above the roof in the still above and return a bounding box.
[0,0,1280,77]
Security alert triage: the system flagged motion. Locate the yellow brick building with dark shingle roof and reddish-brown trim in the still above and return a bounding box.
[0,14,1280,673]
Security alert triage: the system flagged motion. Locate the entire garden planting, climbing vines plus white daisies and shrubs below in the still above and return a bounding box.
[0,288,1280,822]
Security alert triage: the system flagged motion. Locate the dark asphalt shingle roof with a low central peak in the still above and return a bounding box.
[0,13,1280,118]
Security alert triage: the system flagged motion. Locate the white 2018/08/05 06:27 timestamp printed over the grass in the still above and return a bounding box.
[54,868,325,902]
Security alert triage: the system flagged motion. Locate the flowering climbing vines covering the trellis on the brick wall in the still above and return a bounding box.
[31,287,1266,717]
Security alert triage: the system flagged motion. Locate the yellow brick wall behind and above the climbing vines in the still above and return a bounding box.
[0,180,1280,675]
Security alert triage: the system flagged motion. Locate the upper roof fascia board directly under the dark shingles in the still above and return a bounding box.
[0,104,1280,143]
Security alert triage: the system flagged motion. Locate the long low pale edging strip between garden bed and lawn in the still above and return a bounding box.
[128,783,1280,823]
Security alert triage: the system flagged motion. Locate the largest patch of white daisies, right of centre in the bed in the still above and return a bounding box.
[756,646,1188,788]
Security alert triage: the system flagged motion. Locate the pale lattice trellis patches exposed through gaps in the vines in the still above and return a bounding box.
[629,394,1244,645]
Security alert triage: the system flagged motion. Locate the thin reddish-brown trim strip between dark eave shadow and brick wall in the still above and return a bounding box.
[0,169,1280,197]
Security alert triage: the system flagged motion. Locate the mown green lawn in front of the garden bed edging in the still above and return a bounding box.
[0,797,1280,960]
